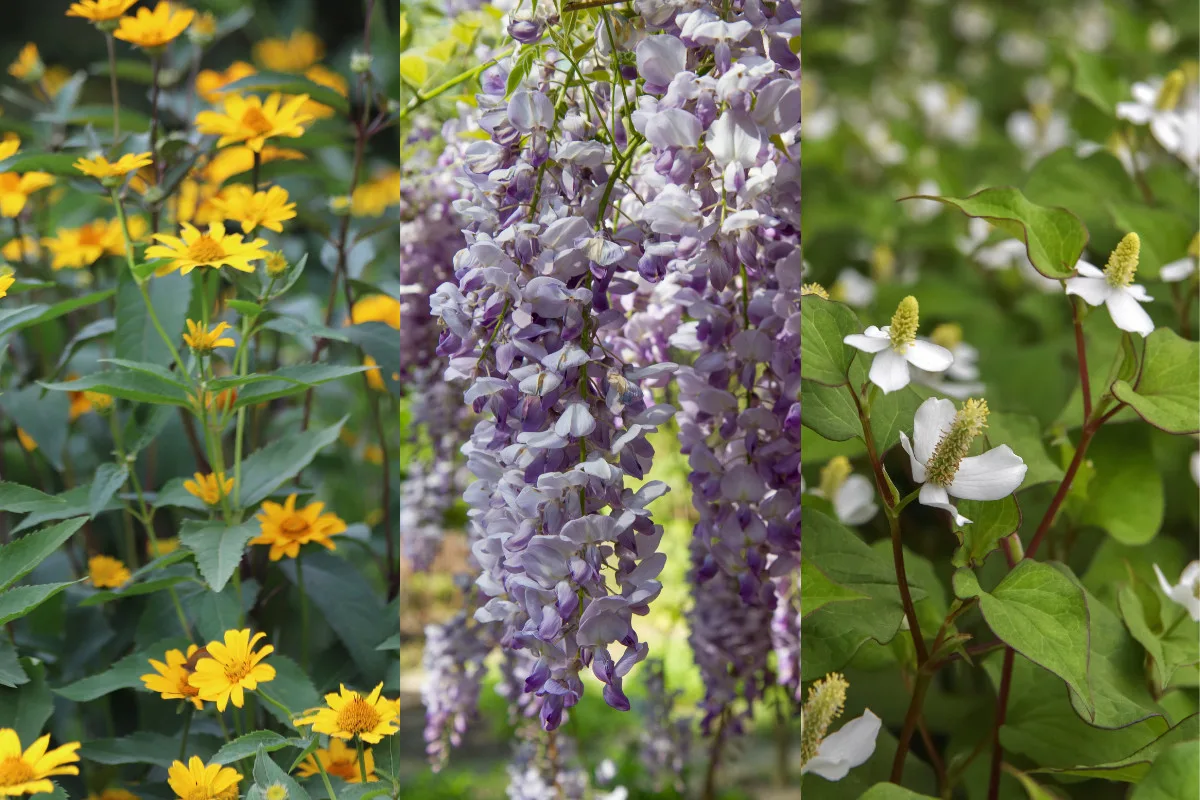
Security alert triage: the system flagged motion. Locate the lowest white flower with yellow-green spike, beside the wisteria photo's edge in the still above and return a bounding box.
[800,673,882,781]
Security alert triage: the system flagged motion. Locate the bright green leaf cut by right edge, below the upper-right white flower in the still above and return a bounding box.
[1112,327,1200,433]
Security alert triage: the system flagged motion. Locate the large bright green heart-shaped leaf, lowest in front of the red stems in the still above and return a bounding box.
[954,559,1096,717]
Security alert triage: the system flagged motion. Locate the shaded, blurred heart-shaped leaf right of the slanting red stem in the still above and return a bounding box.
[1080,425,1164,545]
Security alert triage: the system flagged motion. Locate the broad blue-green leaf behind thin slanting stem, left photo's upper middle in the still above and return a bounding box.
[113,272,192,365]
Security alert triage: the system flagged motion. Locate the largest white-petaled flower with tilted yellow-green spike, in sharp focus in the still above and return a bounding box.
[900,397,1028,525]
